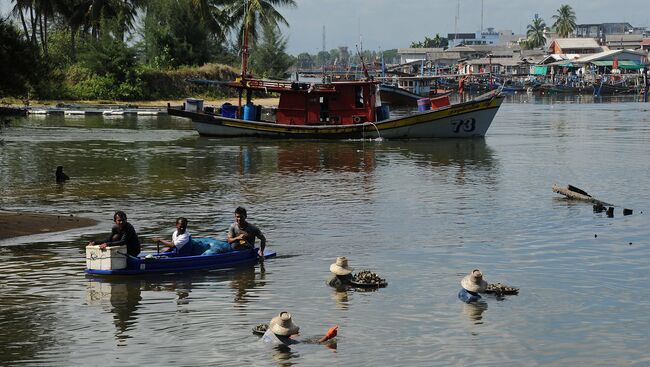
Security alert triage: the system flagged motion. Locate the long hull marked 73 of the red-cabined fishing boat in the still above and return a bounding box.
[169,93,503,139]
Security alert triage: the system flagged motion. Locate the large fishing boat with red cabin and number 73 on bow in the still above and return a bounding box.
[167,4,503,139]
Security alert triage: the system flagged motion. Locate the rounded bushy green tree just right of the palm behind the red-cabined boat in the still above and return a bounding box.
[251,25,293,79]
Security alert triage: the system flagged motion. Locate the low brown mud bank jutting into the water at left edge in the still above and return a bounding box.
[0,212,97,240]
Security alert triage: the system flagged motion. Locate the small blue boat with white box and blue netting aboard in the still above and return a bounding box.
[86,238,276,275]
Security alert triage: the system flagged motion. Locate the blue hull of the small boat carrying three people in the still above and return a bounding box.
[86,249,276,275]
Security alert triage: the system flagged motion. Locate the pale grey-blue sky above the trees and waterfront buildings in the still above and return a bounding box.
[0,0,650,55]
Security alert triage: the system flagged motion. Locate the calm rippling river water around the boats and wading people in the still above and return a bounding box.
[0,95,650,366]
